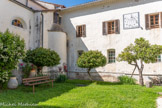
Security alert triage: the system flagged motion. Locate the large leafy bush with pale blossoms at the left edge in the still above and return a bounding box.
[0,30,25,87]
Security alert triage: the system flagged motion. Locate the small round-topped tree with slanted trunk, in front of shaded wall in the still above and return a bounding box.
[77,51,106,81]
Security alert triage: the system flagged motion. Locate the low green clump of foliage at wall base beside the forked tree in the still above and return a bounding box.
[119,76,136,85]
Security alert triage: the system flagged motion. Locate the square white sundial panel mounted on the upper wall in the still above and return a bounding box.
[123,12,140,29]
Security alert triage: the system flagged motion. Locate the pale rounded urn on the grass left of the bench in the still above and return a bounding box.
[8,77,18,89]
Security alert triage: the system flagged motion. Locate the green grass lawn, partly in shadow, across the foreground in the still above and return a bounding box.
[0,80,162,108]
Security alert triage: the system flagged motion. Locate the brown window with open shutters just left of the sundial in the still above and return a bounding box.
[103,20,120,35]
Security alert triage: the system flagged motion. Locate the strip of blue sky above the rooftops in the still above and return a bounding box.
[41,0,95,7]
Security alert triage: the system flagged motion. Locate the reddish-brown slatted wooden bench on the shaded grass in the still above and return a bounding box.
[23,76,54,94]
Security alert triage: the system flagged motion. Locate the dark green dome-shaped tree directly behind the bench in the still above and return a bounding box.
[23,48,60,73]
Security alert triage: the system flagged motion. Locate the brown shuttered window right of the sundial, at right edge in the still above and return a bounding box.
[145,13,162,29]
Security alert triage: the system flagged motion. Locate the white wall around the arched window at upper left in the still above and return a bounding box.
[0,0,34,49]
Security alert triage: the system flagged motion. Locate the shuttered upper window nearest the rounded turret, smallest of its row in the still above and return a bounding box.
[76,25,86,37]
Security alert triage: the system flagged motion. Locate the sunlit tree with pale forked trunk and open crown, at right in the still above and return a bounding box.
[117,38,162,86]
